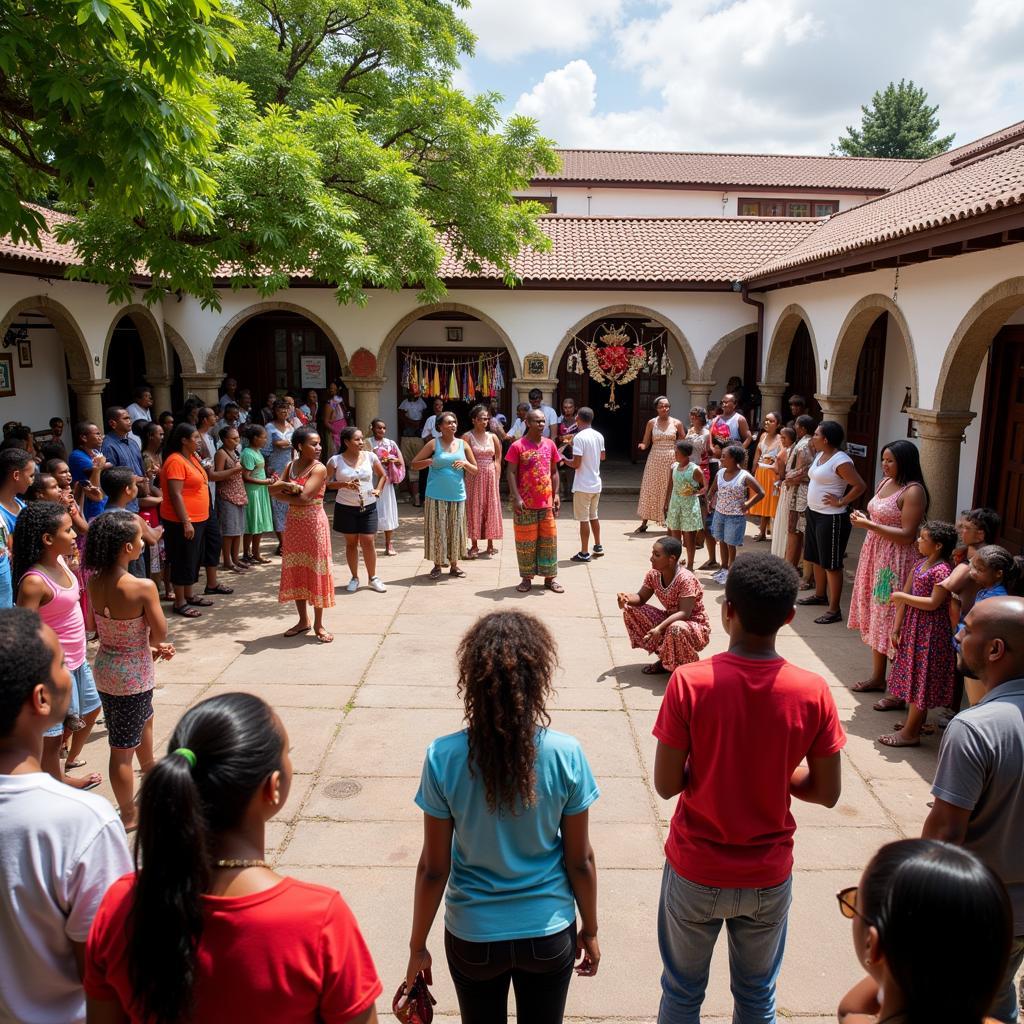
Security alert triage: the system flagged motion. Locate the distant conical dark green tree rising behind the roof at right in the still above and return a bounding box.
[833,79,954,160]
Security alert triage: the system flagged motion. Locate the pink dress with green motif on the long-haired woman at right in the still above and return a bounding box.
[849,480,920,654]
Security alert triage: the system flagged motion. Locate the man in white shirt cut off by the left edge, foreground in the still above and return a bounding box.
[0,608,132,1024]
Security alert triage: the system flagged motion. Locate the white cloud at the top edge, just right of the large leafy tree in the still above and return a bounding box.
[462,0,623,60]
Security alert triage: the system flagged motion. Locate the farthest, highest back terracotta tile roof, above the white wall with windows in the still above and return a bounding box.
[534,150,921,193]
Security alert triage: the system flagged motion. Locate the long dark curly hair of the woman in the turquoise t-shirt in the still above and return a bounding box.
[458,611,558,813]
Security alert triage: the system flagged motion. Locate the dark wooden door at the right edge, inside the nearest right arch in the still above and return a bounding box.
[975,327,1024,554]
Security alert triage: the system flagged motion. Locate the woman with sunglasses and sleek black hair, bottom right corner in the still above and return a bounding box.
[836,839,1013,1024]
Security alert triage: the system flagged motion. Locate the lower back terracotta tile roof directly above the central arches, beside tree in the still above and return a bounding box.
[441,216,821,285]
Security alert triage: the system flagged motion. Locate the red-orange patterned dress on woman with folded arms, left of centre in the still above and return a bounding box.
[278,463,334,608]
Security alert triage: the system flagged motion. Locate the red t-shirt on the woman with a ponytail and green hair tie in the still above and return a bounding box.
[85,874,382,1024]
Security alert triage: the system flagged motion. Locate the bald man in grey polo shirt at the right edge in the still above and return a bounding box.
[922,597,1024,1024]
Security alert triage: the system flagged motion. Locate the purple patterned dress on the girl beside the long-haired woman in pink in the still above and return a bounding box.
[889,559,955,711]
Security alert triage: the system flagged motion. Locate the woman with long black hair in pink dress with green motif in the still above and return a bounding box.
[850,440,928,711]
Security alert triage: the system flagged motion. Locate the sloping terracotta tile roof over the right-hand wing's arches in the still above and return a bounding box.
[746,138,1024,280]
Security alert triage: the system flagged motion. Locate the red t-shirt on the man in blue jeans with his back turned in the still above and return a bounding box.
[654,654,846,889]
